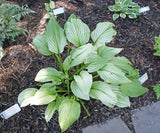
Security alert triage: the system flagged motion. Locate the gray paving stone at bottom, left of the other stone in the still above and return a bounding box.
[83,117,131,133]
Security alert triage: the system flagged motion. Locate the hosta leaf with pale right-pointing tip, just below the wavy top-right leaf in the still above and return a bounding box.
[97,46,122,61]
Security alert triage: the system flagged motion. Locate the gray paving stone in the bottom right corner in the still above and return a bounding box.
[132,102,160,133]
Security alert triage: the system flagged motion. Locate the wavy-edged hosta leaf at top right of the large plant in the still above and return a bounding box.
[91,22,117,45]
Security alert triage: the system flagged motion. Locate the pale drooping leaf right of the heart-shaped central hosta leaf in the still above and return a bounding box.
[89,81,117,107]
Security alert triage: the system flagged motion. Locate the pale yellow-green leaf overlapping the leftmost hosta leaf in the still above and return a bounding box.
[30,83,56,105]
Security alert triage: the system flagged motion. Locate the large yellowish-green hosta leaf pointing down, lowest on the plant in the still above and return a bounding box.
[58,98,81,132]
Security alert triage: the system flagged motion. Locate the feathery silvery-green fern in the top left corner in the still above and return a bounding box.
[0,1,34,59]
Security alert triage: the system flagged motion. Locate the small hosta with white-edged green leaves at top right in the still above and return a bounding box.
[108,0,140,21]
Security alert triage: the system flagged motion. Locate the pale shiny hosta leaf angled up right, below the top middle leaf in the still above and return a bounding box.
[71,43,93,66]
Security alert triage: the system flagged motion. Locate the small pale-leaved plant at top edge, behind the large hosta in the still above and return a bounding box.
[43,0,56,19]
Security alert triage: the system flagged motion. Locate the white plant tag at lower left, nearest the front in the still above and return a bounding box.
[0,104,21,119]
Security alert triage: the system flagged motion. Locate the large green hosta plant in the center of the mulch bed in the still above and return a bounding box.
[18,15,148,132]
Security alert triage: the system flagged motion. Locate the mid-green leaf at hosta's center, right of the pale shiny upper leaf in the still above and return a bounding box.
[84,53,107,72]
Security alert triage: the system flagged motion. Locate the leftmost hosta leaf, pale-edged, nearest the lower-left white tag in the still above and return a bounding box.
[18,88,38,107]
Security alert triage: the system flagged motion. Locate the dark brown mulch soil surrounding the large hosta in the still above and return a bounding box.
[0,0,160,133]
